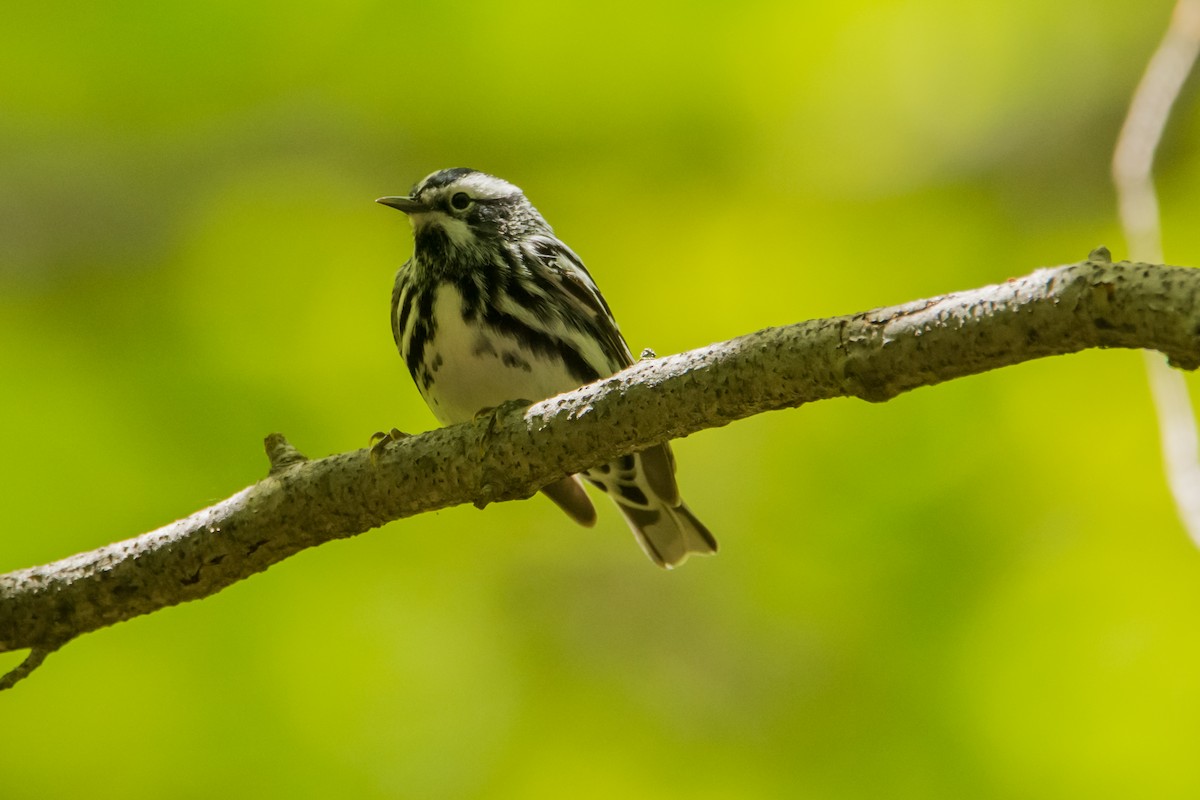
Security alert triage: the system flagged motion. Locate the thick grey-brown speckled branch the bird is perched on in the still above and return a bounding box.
[0,255,1200,687]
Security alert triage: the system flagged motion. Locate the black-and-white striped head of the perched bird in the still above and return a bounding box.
[376,167,553,257]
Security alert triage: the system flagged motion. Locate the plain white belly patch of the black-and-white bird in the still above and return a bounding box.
[420,283,580,425]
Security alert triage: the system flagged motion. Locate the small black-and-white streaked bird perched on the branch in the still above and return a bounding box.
[376,167,716,569]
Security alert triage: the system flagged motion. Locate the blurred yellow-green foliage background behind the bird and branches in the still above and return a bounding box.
[0,0,1200,799]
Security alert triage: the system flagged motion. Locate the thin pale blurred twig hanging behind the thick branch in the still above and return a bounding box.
[1112,0,1200,546]
